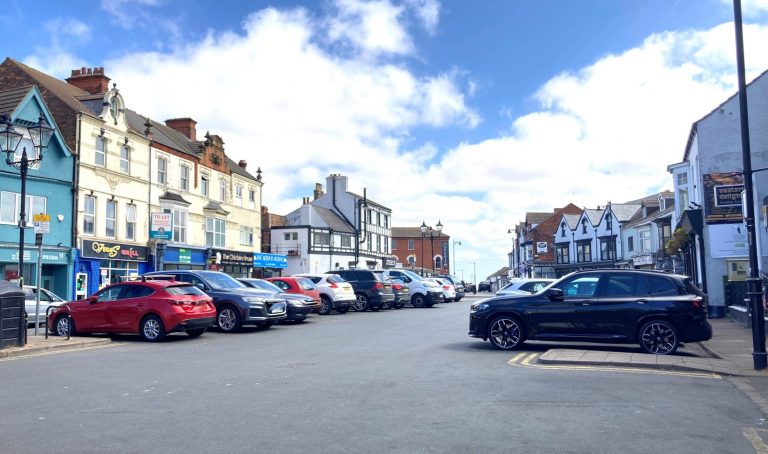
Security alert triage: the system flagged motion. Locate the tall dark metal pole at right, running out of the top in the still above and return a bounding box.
[733,0,768,370]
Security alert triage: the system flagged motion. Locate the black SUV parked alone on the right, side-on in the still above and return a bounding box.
[469,269,712,355]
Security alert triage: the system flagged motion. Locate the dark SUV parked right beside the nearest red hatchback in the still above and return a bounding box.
[146,270,287,333]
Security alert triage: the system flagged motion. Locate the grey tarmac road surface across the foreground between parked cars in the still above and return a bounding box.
[0,298,768,454]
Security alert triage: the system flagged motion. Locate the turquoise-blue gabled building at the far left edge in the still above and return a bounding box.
[0,86,74,299]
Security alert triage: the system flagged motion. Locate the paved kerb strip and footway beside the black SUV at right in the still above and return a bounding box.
[537,318,768,377]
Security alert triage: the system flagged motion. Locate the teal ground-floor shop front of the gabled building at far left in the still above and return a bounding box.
[0,245,72,300]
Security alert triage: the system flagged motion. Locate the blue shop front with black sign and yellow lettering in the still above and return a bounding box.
[75,240,151,298]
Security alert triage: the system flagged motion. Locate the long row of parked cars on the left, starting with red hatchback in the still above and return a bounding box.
[47,269,468,341]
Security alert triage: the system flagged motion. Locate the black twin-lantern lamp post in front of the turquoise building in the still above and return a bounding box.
[0,115,53,343]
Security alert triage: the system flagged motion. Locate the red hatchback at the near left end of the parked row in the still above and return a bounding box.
[48,280,216,342]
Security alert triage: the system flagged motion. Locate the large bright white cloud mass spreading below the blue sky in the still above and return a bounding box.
[96,0,768,279]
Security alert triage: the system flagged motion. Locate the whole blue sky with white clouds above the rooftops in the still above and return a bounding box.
[0,0,768,282]
